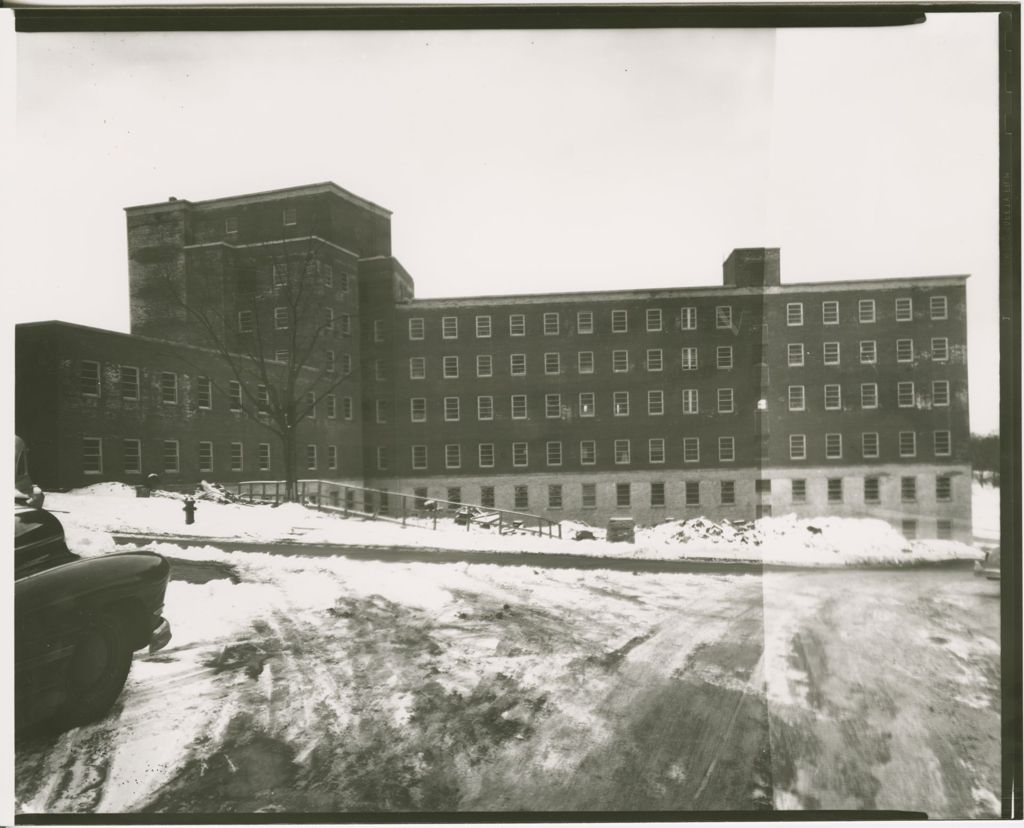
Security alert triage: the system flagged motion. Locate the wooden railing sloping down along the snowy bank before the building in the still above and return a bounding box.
[228,480,562,537]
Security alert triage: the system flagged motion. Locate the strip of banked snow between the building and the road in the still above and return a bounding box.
[46,483,998,566]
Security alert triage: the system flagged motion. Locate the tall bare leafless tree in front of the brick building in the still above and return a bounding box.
[153,223,351,500]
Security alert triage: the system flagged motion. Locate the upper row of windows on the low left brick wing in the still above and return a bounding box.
[78,362,353,420]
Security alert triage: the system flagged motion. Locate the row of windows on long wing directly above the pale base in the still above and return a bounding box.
[377,431,952,471]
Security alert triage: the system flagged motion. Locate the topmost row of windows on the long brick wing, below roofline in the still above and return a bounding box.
[409,296,949,341]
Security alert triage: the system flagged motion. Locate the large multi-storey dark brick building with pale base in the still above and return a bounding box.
[18,183,971,537]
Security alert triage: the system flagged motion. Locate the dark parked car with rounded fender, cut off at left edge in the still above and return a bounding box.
[14,505,171,730]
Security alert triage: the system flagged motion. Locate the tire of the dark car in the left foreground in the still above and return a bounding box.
[57,613,132,726]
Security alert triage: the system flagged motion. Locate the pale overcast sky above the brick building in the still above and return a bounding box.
[4,14,998,432]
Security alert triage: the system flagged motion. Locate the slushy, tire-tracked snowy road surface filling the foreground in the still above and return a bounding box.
[15,553,1000,818]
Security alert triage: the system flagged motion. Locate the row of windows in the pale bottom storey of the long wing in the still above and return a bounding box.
[414,475,952,513]
